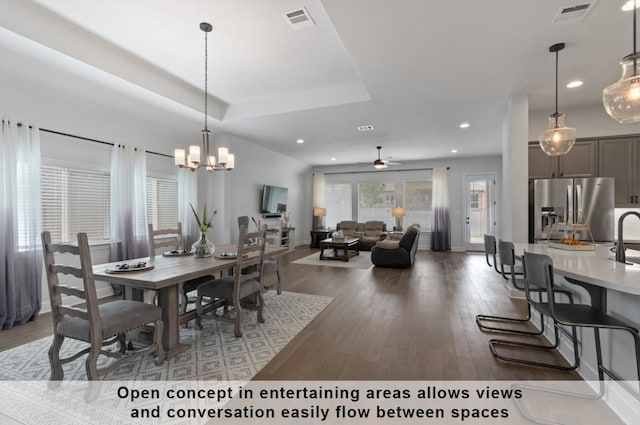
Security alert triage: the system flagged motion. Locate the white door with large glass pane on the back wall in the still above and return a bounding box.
[463,174,496,251]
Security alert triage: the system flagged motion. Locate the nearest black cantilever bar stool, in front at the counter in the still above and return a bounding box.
[490,252,640,380]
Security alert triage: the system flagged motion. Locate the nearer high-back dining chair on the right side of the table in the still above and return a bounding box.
[196,225,266,338]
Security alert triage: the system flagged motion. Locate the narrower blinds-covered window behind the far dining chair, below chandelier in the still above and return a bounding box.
[147,177,178,229]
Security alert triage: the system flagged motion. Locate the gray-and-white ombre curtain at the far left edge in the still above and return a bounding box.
[0,118,42,329]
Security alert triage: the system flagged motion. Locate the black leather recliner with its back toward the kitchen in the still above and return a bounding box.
[371,224,420,267]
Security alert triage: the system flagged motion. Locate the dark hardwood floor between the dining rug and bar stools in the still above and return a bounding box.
[0,246,580,380]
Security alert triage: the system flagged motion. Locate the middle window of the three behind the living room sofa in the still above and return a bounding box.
[358,182,396,229]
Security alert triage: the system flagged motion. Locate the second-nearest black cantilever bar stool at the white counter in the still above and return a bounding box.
[476,240,573,336]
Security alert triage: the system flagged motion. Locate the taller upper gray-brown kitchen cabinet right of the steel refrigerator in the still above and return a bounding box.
[598,137,640,207]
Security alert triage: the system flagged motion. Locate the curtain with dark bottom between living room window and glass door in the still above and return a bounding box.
[431,167,451,251]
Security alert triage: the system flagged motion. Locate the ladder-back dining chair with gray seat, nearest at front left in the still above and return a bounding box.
[42,232,164,381]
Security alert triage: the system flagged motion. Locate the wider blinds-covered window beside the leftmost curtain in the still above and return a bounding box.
[41,165,109,242]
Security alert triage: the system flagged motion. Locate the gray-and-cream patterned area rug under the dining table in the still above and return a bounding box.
[0,291,333,380]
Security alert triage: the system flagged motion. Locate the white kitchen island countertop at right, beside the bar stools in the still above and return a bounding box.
[515,243,640,295]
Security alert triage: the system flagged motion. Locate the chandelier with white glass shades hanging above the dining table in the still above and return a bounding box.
[173,22,235,171]
